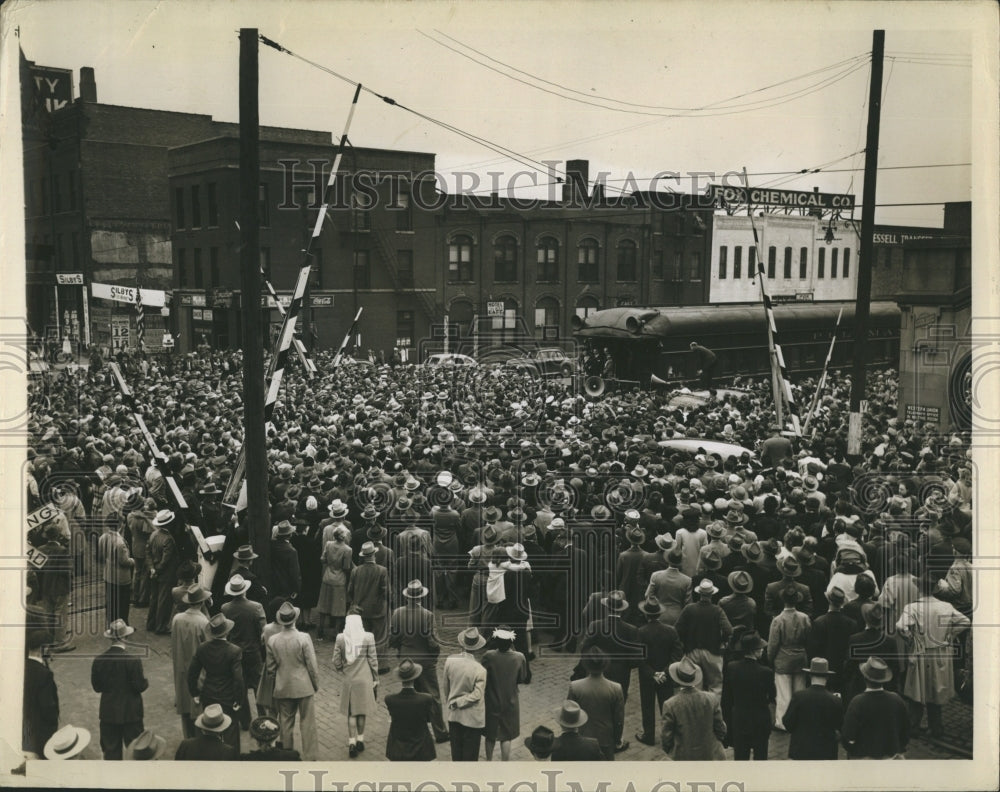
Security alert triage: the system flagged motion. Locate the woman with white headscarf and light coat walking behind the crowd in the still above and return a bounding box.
[333,608,378,759]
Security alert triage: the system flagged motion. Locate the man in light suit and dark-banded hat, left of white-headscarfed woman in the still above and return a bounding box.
[267,601,319,762]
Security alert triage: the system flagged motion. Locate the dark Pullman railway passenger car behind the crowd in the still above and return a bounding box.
[573,302,900,390]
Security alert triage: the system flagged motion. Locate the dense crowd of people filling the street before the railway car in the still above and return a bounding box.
[23,344,974,761]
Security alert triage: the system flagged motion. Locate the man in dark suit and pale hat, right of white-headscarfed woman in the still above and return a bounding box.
[389,580,448,743]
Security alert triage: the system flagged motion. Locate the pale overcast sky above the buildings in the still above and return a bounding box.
[4,0,978,226]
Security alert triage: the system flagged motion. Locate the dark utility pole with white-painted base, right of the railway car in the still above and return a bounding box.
[847,30,885,456]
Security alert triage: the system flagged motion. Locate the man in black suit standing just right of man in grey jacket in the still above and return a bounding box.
[722,630,777,761]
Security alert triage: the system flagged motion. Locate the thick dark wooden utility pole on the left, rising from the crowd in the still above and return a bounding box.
[240,28,271,580]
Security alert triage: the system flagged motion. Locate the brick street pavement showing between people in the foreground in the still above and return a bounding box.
[43,586,972,762]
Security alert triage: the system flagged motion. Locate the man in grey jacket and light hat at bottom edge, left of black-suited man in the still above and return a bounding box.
[660,657,726,762]
